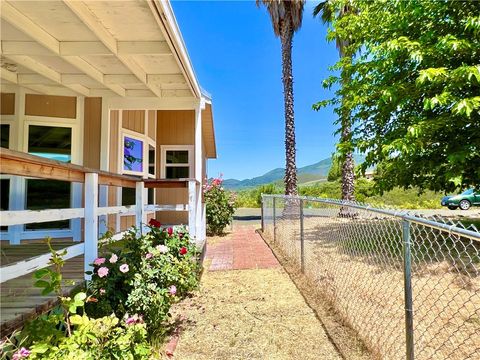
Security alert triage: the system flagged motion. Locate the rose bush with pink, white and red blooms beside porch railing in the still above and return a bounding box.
[86,221,200,338]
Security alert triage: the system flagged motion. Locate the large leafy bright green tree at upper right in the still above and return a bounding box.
[316,0,480,191]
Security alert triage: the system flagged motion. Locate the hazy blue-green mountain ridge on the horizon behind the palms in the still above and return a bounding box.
[223,154,365,190]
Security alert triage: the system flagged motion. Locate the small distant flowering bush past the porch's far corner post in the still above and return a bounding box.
[203,178,236,235]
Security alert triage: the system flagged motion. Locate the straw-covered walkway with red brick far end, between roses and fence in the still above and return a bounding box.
[172,225,341,360]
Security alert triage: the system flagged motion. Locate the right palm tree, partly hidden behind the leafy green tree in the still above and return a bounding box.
[313,0,355,201]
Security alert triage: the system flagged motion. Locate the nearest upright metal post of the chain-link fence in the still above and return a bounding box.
[402,219,414,360]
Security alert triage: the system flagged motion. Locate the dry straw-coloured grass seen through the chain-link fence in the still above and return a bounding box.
[266,218,480,360]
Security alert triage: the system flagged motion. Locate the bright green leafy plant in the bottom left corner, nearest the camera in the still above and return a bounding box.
[0,239,150,360]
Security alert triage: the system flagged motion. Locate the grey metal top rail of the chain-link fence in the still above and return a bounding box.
[262,194,480,241]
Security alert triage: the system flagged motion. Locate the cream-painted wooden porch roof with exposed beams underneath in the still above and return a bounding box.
[1,0,203,99]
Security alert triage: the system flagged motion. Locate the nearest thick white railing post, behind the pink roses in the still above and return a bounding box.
[84,173,98,280]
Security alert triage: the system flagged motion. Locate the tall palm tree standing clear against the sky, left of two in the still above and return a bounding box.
[257,0,305,195]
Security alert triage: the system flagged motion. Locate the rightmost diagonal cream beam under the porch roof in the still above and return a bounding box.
[64,0,162,97]
